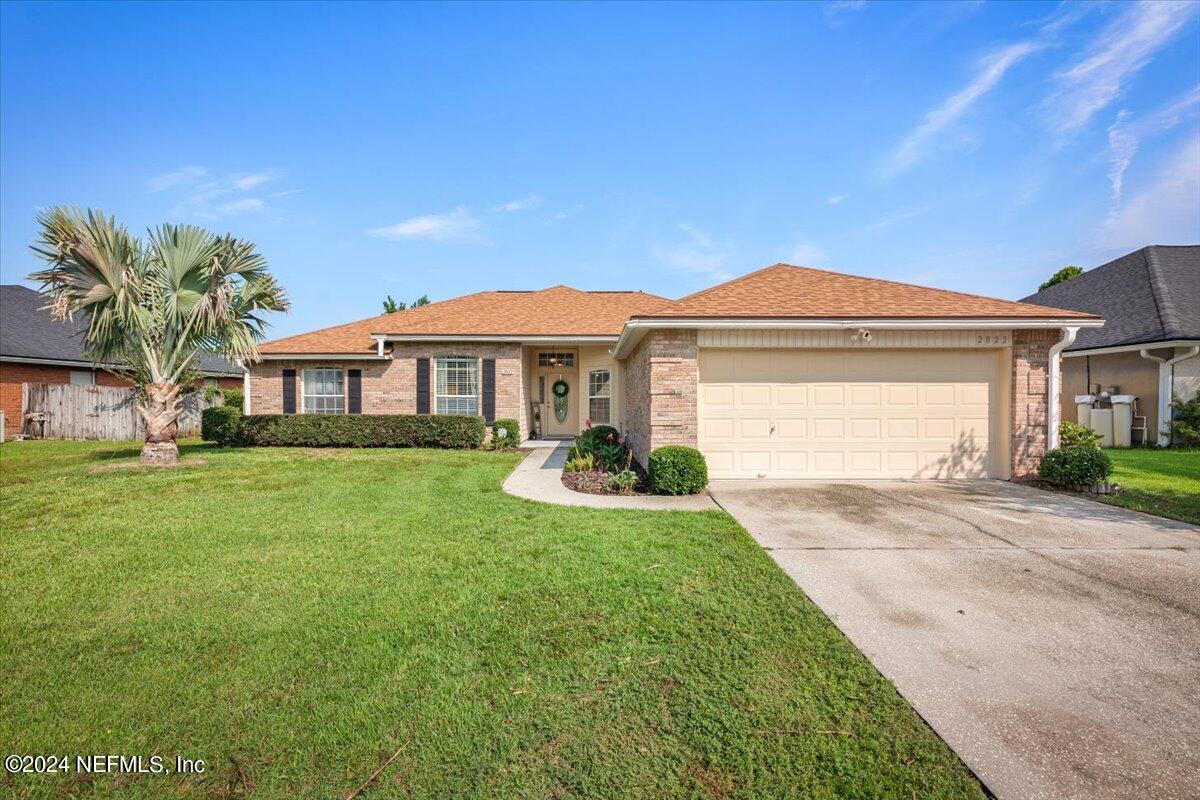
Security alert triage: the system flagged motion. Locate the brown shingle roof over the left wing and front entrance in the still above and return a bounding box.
[260,285,670,355]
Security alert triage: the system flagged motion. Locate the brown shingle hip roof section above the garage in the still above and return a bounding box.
[635,264,1099,319]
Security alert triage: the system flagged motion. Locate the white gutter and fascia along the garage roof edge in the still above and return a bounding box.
[612,317,1104,359]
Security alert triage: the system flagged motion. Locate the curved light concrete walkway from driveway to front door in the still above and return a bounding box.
[504,441,718,511]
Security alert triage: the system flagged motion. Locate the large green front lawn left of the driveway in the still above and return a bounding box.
[0,441,982,799]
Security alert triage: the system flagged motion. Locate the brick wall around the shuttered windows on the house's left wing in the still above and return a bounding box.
[250,342,529,438]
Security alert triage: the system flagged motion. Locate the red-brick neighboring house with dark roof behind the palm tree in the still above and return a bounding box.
[0,284,242,439]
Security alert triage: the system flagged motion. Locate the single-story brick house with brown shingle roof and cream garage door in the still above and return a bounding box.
[246,264,1103,479]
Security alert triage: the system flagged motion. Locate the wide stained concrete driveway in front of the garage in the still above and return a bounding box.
[710,481,1200,800]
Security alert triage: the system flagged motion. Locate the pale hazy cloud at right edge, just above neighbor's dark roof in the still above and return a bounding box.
[1098,130,1200,251]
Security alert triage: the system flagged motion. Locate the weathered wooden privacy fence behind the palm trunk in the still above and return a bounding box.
[22,384,222,440]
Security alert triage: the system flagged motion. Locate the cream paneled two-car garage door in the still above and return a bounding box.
[698,349,1001,479]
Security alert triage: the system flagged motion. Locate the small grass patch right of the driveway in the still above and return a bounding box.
[1096,447,1200,525]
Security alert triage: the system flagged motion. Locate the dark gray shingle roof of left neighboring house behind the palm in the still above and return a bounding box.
[0,284,241,375]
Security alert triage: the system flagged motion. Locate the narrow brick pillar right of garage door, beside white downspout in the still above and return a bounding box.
[1012,330,1060,481]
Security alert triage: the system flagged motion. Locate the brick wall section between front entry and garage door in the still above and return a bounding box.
[625,330,700,464]
